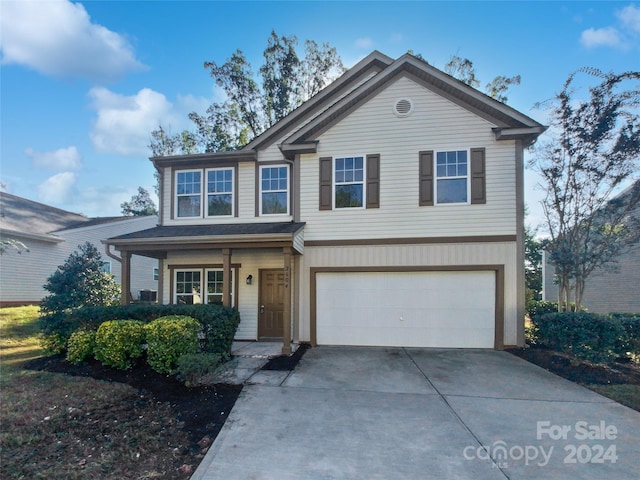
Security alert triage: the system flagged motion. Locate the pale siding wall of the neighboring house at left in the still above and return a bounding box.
[0,216,158,302]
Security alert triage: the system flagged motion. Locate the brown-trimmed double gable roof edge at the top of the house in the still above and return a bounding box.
[244,51,546,159]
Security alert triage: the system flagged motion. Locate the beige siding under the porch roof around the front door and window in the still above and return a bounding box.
[162,249,295,340]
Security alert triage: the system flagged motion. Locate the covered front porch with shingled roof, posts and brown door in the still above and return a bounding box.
[104,222,304,355]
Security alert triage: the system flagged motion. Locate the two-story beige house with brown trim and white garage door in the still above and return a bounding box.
[108,52,545,353]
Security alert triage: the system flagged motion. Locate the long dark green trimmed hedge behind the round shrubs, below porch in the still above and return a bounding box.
[40,304,240,359]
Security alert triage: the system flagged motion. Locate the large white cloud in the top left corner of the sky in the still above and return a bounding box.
[0,0,145,81]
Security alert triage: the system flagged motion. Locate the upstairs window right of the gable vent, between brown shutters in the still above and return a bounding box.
[436,150,469,204]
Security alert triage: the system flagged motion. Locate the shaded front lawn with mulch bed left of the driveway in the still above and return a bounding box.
[0,307,240,479]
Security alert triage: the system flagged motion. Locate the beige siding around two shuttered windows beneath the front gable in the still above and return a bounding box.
[300,77,516,241]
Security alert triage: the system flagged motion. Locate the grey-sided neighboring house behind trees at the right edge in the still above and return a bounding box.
[542,185,640,313]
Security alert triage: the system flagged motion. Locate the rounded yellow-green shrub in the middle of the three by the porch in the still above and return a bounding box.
[95,320,144,370]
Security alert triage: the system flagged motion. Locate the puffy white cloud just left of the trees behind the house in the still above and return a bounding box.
[89,87,210,158]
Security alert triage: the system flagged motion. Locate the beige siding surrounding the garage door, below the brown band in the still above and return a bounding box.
[297,242,524,345]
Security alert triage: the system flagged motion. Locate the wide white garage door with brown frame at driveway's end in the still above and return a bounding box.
[316,271,496,348]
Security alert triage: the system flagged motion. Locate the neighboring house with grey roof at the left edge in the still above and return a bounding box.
[0,192,158,306]
